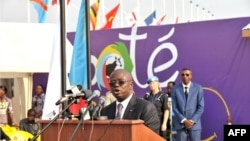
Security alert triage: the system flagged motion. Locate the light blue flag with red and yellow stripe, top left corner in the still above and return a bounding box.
[30,0,49,23]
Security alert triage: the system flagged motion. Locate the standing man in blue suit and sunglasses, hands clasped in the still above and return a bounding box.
[171,68,204,141]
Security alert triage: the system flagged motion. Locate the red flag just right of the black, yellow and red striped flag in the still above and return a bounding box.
[101,3,120,29]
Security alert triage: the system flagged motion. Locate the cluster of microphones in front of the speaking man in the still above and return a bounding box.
[55,85,105,117]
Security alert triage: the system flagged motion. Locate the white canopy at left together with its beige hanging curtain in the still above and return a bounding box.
[0,23,73,124]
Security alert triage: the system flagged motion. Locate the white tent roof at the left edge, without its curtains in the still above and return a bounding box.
[0,23,73,73]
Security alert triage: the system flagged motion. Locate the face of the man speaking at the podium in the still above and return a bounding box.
[109,71,133,101]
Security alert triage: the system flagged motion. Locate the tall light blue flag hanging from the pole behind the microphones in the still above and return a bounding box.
[69,0,89,115]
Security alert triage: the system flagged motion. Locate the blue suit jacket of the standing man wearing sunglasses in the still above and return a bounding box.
[171,83,204,130]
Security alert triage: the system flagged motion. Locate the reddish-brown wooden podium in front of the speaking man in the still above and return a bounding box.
[39,120,165,141]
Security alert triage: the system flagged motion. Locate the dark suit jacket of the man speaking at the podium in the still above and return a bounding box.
[101,94,160,133]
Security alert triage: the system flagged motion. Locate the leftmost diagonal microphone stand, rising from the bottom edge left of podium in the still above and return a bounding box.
[29,98,76,141]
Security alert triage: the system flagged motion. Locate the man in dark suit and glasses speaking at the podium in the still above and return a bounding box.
[101,69,160,134]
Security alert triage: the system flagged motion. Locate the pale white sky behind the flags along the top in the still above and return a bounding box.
[0,0,250,31]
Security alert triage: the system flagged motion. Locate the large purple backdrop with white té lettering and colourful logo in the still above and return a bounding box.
[68,17,250,141]
